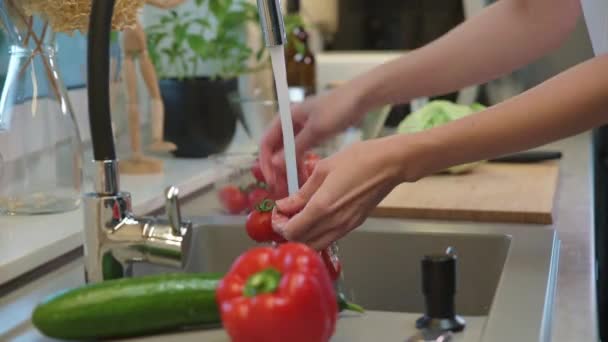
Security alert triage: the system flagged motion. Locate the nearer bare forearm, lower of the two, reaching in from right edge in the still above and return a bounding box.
[394,55,608,181]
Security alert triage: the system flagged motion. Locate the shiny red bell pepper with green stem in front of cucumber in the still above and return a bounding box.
[217,243,338,342]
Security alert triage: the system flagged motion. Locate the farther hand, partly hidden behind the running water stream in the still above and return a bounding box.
[260,85,366,196]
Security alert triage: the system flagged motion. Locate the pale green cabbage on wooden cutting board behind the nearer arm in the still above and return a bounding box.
[397,100,486,174]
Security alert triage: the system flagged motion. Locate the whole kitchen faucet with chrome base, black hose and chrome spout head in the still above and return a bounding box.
[84,0,286,282]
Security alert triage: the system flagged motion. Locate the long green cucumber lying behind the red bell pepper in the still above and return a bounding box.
[32,273,363,340]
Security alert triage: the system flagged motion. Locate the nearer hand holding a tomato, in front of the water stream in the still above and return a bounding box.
[273,138,408,250]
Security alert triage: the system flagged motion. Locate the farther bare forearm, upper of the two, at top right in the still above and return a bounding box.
[350,0,580,109]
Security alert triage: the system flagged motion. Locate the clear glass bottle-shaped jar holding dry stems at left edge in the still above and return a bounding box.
[0,0,82,215]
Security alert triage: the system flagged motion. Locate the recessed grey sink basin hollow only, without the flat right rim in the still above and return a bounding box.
[134,217,511,316]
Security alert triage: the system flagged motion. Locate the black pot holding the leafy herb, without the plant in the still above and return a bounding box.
[160,78,238,158]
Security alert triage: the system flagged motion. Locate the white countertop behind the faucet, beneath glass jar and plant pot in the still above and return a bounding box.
[0,125,255,285]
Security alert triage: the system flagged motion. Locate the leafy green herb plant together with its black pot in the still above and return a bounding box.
[146,0,269,157]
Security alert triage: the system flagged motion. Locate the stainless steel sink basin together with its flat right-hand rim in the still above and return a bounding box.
[134,216,559,341]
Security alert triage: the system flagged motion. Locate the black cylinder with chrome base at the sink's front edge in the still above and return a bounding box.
[416,253,465,332]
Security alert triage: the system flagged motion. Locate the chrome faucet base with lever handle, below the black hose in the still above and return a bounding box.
[84,161,192,282]
